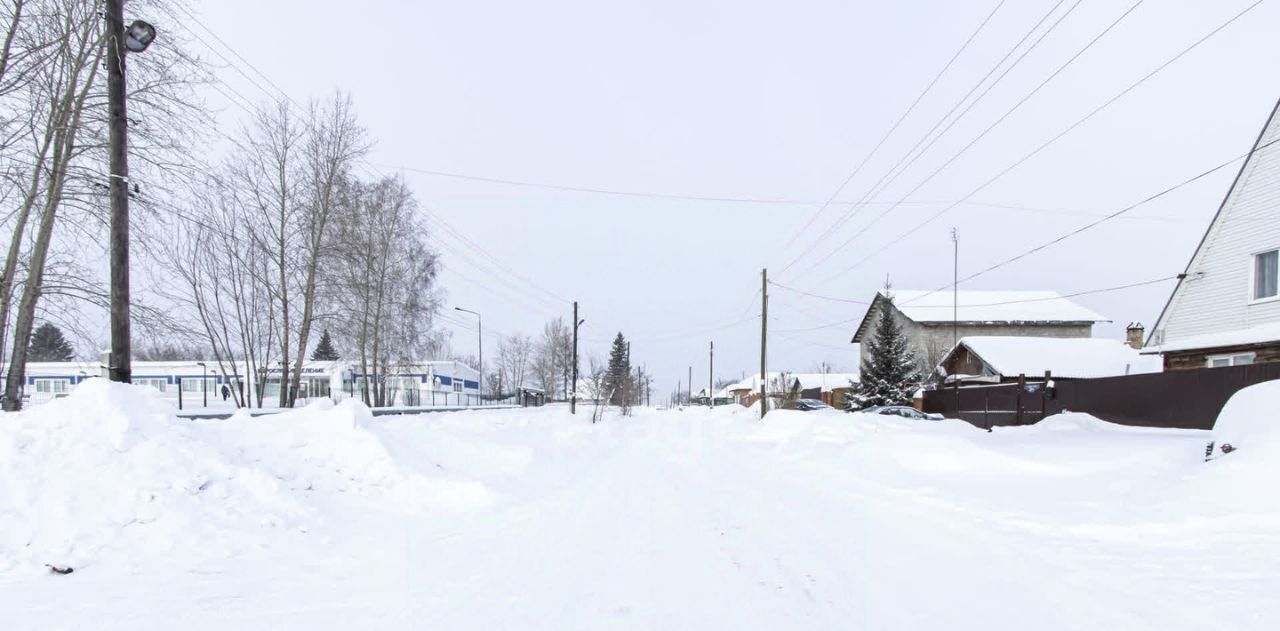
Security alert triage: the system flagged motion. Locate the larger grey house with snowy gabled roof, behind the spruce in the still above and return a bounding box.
[852,289,1107,374]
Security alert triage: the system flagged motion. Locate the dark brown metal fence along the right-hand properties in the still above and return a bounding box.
[924,363,1280,429]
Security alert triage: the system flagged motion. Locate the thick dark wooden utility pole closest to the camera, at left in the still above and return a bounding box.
[104,0,133,383]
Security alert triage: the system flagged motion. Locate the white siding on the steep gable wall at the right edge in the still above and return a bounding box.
[1149,101,1280,346]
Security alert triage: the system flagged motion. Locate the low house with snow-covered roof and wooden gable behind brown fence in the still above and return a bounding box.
[934,335,1161,385]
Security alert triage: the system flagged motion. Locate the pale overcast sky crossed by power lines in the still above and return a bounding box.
[183,0,1280,394]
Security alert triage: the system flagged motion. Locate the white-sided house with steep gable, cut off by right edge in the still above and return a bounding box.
[1146,104,1280,370]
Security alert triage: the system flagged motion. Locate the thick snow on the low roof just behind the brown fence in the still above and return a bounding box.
[943,335,1162,379]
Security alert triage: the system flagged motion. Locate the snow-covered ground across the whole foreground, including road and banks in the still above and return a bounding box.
[0,380,1280,630]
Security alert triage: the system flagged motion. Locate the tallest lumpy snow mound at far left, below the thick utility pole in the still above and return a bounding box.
[0,379,302,572]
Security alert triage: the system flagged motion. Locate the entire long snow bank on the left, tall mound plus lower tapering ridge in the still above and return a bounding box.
[0,379,489,573]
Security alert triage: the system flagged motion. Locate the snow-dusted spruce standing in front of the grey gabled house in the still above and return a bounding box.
[849,298,920,408]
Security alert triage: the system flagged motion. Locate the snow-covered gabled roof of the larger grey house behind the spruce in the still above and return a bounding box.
[852,289,1107,342]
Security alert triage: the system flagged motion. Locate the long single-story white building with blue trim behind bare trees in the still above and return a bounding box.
[0,360,480,408]
